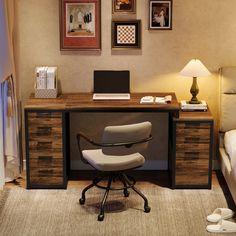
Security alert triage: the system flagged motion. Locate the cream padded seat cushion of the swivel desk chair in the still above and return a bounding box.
[82,149,145,171]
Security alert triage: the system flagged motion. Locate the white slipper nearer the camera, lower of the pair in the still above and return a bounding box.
[206,220,236,233]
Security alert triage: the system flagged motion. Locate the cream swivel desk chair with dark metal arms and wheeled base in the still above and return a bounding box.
[77,121,152,221]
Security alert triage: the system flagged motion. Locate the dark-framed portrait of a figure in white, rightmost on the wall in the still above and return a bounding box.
[149,0,172,30]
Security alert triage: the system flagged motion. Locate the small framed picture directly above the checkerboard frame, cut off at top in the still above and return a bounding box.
[112,0,136,14]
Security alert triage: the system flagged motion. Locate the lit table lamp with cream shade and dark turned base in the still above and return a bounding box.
[180,59,211,104]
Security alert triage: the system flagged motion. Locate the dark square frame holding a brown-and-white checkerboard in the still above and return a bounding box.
[111,20,141,49]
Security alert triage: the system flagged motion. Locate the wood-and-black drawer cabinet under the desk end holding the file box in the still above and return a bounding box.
[25,111,67,188]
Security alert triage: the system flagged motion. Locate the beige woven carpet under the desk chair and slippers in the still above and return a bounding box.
[0,184,233,236]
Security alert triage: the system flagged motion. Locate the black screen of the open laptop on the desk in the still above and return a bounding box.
[93,70,130,93]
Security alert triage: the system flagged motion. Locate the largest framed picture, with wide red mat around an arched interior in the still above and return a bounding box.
[60,0,101,50]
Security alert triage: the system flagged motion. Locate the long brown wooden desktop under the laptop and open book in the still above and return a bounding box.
[24,92,179,112]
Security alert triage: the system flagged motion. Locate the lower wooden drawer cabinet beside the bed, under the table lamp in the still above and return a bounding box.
[172,111,213,188]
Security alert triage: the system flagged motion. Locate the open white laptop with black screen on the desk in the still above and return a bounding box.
[93,70,130,100]
